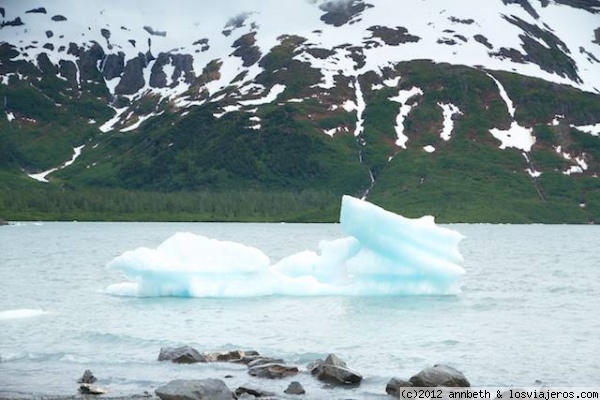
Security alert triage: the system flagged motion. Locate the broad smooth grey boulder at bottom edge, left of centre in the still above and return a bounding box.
[155,379,236,400]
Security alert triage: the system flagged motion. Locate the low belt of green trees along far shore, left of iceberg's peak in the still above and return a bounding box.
[0,185,339,222]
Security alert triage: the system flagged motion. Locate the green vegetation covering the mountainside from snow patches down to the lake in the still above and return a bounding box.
[0,52,600,223]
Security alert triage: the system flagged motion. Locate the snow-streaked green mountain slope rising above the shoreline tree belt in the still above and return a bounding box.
[0,0,600,222]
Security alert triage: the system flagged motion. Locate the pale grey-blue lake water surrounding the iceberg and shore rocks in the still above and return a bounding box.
[0,222,600,399]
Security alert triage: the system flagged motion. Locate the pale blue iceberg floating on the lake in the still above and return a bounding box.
[105,196,465,297]
